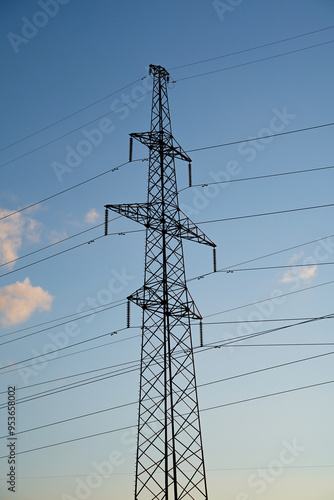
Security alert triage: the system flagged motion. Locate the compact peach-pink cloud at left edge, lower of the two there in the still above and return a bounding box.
[0,278,53,326]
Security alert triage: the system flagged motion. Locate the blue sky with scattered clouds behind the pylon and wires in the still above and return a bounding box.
[0,0,334,500]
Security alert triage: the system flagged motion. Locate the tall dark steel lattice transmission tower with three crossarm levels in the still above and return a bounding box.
[105,65,215,500]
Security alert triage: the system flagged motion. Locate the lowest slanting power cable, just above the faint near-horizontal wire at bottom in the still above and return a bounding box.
[0,380,334,459]
